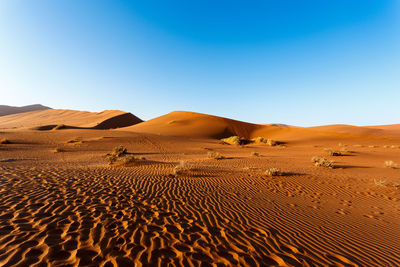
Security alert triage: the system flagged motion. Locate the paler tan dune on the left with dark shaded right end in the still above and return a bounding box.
[0,109,142,130]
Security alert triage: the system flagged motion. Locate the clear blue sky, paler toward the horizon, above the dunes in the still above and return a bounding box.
[0,0,400,126]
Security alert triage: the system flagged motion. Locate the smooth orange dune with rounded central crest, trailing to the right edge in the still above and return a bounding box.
[123,111,400,140]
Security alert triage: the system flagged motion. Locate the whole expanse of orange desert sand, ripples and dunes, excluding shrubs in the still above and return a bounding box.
[0,110,400,266]
